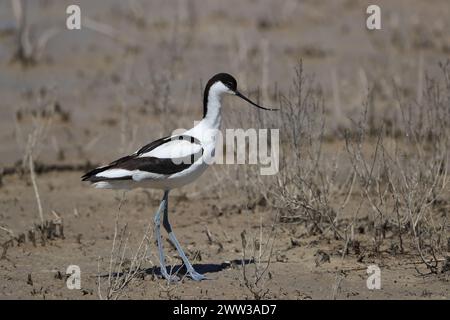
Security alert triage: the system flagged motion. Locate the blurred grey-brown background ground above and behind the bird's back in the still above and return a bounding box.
[0,0,450,166]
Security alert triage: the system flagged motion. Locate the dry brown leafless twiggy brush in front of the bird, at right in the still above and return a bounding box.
[262,62,450,273]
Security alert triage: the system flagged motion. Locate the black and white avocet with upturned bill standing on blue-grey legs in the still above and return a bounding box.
[82,73,276,281]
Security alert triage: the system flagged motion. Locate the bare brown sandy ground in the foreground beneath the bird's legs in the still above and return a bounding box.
[1,173,450,299]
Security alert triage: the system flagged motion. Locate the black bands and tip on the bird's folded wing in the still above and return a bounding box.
[81,135,203,182]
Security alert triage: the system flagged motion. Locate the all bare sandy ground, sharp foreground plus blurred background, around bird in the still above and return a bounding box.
[0,0,450,299]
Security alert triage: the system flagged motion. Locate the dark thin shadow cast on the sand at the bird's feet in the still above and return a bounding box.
[100,259,254,278]
